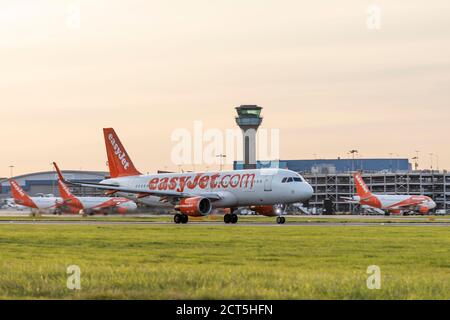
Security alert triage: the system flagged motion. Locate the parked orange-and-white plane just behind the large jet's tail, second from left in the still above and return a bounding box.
[53,162,137,216]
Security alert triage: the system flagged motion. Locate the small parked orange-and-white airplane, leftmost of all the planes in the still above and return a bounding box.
[9,179,61,213]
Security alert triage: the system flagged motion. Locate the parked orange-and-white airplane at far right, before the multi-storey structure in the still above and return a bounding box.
[344,172,436,214]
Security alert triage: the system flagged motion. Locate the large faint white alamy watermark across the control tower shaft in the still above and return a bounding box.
[171,121,280,166]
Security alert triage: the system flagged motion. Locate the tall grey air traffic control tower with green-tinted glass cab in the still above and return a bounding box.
[236,105,263,169]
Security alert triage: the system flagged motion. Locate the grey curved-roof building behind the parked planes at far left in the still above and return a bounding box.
[0,170,109,199]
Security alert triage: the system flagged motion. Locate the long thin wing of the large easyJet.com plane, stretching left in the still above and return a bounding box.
[64,181,222,200]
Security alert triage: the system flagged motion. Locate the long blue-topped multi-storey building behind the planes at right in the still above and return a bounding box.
[234,158,450,213]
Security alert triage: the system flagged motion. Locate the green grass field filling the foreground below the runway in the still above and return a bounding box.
[0,225,450,299]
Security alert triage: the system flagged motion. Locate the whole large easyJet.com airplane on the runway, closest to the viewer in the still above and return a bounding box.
[56,128,314,224]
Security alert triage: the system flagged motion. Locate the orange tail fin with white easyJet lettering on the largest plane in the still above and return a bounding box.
[103,128,141,178]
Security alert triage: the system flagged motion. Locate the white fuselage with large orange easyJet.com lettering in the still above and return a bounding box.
[101,169,314,208]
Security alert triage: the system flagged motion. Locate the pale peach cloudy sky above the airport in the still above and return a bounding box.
[0,0,450,177]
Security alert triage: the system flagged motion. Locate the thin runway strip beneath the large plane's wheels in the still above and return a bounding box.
[0,220,450,228]
